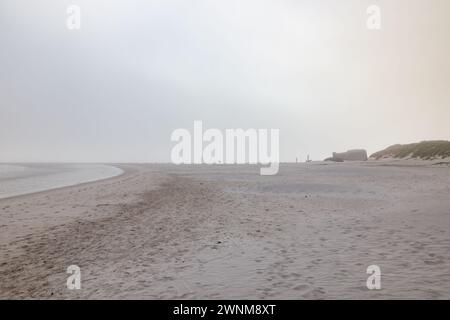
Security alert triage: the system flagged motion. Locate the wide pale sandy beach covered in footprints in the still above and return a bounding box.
[0,162,450,299]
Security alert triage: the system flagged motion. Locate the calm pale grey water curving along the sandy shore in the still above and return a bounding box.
[0,163,123,199]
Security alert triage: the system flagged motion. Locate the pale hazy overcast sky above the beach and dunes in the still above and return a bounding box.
[0,0,450,162]
